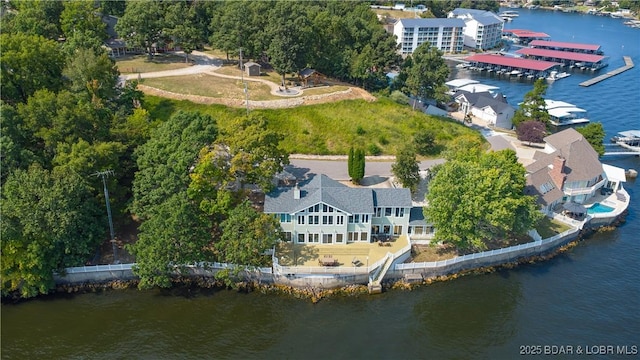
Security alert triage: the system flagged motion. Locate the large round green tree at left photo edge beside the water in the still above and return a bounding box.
[0,166,107,298]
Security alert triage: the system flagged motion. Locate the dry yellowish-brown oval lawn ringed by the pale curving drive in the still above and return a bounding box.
[141,74,282,100]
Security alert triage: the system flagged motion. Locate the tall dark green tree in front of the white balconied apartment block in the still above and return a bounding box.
[402,42,449,108]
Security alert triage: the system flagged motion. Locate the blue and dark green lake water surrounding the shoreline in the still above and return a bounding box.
[1,9,640,359]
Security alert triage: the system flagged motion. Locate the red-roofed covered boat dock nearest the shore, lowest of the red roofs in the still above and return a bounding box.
[465,54,561,79]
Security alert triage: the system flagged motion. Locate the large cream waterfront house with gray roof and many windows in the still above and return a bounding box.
[264,175,433,244]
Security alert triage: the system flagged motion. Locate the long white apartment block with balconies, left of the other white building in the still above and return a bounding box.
[393,19,465,55]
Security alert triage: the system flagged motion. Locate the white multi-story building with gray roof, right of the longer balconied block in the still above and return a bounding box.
[448,8,504,50]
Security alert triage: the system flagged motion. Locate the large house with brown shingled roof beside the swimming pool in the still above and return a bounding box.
[525,128,625,213]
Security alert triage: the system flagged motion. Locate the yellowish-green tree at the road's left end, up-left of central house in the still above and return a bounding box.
[214,114,289,191]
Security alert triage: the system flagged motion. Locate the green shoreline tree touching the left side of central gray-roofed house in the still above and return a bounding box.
[215,201,283,281]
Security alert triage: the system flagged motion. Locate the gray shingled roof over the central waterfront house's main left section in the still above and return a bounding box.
[264,175,378,214]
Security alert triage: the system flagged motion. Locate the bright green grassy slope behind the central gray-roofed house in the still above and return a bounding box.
[145,95,484,156]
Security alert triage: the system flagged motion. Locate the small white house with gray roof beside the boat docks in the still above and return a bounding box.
[454,90,516,129]
